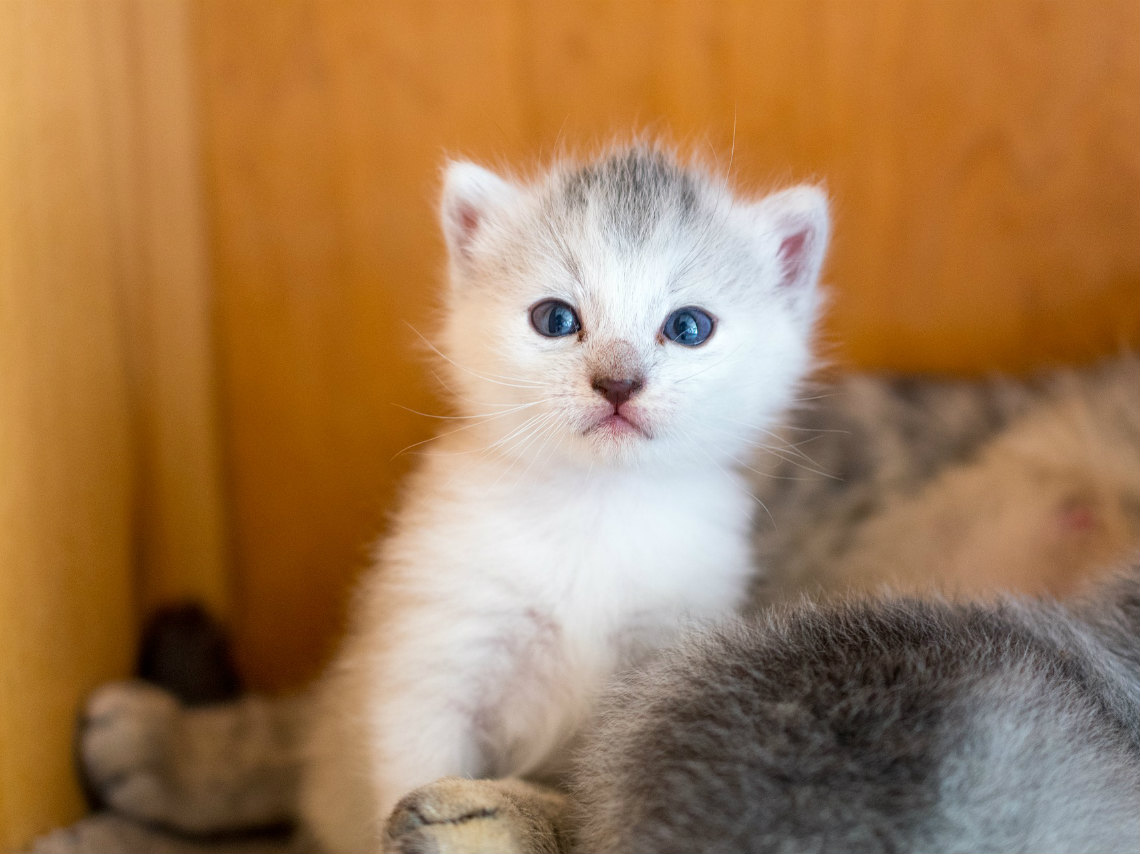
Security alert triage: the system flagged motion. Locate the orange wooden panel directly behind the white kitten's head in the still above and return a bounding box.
[201,0,1140,686]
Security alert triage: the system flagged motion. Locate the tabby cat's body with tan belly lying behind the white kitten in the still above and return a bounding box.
[751,355,1140,607]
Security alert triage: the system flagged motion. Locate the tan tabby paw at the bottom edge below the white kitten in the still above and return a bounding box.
[384,776,565,854]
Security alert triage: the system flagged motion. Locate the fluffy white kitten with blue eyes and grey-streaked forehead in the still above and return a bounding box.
[302,146,828,852]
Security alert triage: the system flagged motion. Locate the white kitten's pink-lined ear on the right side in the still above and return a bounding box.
[755,185,830,299]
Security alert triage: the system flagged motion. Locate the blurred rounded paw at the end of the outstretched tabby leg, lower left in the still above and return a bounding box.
[79,682,182,822]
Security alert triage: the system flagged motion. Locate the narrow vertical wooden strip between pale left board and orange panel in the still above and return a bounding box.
[103,0,231,618]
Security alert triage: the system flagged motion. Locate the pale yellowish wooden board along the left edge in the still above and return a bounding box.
[0,2,133,851]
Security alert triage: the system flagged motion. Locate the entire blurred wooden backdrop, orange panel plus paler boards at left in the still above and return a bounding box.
[0,0,1140,849]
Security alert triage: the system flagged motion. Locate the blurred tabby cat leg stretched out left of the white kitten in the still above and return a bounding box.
[79,682,308,833]
